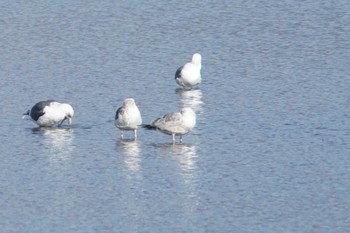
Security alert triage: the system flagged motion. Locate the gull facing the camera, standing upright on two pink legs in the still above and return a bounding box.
[115,98,142,139]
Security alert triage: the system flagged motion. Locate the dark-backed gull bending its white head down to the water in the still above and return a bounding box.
[23,100,74,127]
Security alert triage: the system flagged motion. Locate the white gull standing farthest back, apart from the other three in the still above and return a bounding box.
[175,53,202,89]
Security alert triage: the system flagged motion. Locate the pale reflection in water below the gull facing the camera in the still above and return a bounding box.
[117,140,141,172]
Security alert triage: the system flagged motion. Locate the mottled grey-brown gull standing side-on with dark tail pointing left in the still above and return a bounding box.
[143,107,196,143]
